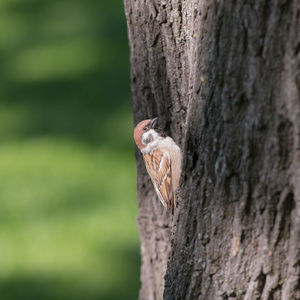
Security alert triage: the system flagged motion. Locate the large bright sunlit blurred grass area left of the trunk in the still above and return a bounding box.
[0,139,139,298]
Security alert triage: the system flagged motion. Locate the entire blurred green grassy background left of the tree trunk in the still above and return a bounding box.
[0,0,140,300]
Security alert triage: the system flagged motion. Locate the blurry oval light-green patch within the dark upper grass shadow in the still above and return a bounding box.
[6,39,101,81]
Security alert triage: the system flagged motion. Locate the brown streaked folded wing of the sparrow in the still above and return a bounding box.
[143,149,175,214]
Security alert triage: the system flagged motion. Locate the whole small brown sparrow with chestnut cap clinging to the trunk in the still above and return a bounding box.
[133,118,182,215]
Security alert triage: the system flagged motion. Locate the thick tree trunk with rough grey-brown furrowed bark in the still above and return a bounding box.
[124,0,300,300]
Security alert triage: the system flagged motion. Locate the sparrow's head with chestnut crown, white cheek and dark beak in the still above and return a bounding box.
[133,118,166,150]
